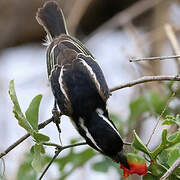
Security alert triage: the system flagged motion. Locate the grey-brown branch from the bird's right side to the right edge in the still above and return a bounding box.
[110,75,180,92]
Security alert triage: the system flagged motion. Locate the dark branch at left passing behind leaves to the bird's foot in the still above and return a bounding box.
[0,118,53,158]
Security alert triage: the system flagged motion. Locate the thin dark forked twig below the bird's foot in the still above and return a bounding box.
[39,142,87,180]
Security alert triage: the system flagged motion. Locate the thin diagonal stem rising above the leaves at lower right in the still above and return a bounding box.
[146,92,176,146]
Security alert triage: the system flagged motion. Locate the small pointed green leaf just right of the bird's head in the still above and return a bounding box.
[132,130,151,158]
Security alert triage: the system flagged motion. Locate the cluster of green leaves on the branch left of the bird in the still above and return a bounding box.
[9,81,50,172]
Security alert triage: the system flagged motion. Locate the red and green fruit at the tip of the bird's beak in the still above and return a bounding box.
[120,153,147,178]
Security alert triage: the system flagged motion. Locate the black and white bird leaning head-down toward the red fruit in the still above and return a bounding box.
[36,1,129,168]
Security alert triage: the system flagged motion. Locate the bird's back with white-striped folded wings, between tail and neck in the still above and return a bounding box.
[47,35,109,115]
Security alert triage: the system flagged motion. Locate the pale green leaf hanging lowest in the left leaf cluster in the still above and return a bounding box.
[31,144,46,172]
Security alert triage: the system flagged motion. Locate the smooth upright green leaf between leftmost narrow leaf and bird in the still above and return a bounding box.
[25,94,42,132]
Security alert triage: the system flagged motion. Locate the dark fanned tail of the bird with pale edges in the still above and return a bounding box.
[36,1,68,41]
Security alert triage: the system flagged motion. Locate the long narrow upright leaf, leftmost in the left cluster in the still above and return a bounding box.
[9,80,33,134]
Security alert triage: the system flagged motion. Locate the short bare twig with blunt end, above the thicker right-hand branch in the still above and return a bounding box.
[129,55,180,62]
